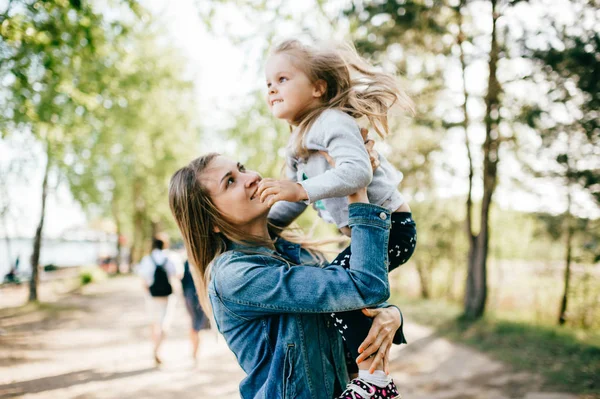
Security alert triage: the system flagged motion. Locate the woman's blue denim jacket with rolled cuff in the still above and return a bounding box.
[209,203,391,399]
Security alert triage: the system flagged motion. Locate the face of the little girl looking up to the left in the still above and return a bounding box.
[265,54,324,125]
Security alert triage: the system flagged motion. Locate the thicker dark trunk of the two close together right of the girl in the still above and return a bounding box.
[464,0,501,319]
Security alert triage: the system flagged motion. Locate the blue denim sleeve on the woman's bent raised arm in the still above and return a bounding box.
[211,203,391,318]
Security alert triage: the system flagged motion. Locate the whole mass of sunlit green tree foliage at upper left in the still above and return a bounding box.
[0,0,199,266]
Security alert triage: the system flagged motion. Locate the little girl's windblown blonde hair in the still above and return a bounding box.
[272,39,414,156]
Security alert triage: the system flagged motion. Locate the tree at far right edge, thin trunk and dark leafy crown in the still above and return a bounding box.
[521,0,600,325]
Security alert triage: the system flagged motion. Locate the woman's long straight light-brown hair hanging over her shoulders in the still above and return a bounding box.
[169,153,330,316]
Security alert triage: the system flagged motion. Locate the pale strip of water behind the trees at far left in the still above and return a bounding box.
[0,238,117,282]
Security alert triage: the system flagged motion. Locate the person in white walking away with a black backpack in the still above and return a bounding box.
[137,233,182,365]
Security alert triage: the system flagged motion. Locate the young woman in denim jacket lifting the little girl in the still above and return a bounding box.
[169,154,401,399]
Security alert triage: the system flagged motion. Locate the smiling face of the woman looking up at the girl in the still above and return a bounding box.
[200,155,269,228]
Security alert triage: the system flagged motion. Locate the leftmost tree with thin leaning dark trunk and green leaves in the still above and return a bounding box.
[0,0,137,301]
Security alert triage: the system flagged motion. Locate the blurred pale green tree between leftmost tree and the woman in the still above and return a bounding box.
[61,25,199,268]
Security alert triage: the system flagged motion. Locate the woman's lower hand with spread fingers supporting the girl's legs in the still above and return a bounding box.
[356,306,402,374]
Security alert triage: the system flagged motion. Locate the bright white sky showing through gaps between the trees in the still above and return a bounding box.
[0,0,600,241]
